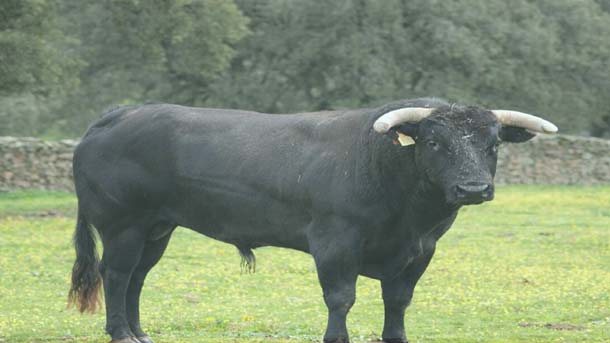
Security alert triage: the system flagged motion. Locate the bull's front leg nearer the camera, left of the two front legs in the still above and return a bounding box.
[309,220,360,343]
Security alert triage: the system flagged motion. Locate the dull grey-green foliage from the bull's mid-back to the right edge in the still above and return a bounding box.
[215,0,610,133]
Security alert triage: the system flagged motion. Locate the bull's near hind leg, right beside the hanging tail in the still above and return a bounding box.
[100,227,146,343]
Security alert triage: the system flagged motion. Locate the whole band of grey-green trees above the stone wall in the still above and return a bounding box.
[0,0,610,138]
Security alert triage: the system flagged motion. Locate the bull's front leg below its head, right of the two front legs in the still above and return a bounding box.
[381,247,434,343]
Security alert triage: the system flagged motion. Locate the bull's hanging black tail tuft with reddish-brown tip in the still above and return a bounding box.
[68,210,102,313]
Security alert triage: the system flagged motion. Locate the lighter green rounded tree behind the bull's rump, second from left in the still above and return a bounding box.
[54,0,248,132]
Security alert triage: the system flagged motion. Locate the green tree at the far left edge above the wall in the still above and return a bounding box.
[0,0,83,135]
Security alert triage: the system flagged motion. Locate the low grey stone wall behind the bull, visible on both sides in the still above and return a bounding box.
[0,135,610,191]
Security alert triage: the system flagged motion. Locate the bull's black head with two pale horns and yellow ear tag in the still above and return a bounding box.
[374,106,557,205]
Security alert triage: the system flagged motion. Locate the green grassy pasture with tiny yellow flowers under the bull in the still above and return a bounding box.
[0,186,610,343]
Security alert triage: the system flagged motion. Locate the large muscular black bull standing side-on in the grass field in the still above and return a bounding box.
[70,99,548,343]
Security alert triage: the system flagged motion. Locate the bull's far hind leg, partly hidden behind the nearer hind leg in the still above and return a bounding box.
[126,229,173,343]
